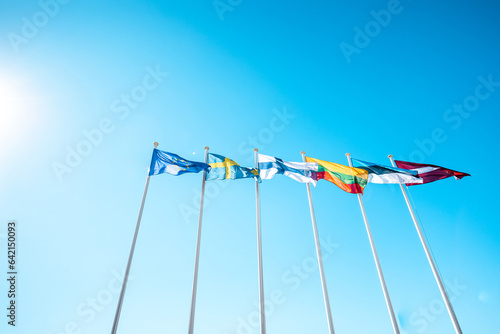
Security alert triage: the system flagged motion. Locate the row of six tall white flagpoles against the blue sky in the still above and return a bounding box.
[111,142,462,334]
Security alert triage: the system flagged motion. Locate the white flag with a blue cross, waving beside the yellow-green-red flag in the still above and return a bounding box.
[258,154,318,186]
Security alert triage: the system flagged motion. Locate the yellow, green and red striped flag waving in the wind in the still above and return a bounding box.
[306,157,368,194]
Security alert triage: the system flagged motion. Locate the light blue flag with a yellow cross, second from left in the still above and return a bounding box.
[207,153,260,182]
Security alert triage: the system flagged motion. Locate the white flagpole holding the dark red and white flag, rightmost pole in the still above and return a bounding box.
[388,154,462,334]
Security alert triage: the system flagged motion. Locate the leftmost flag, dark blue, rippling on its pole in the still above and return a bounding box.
[149,148,210,175]
